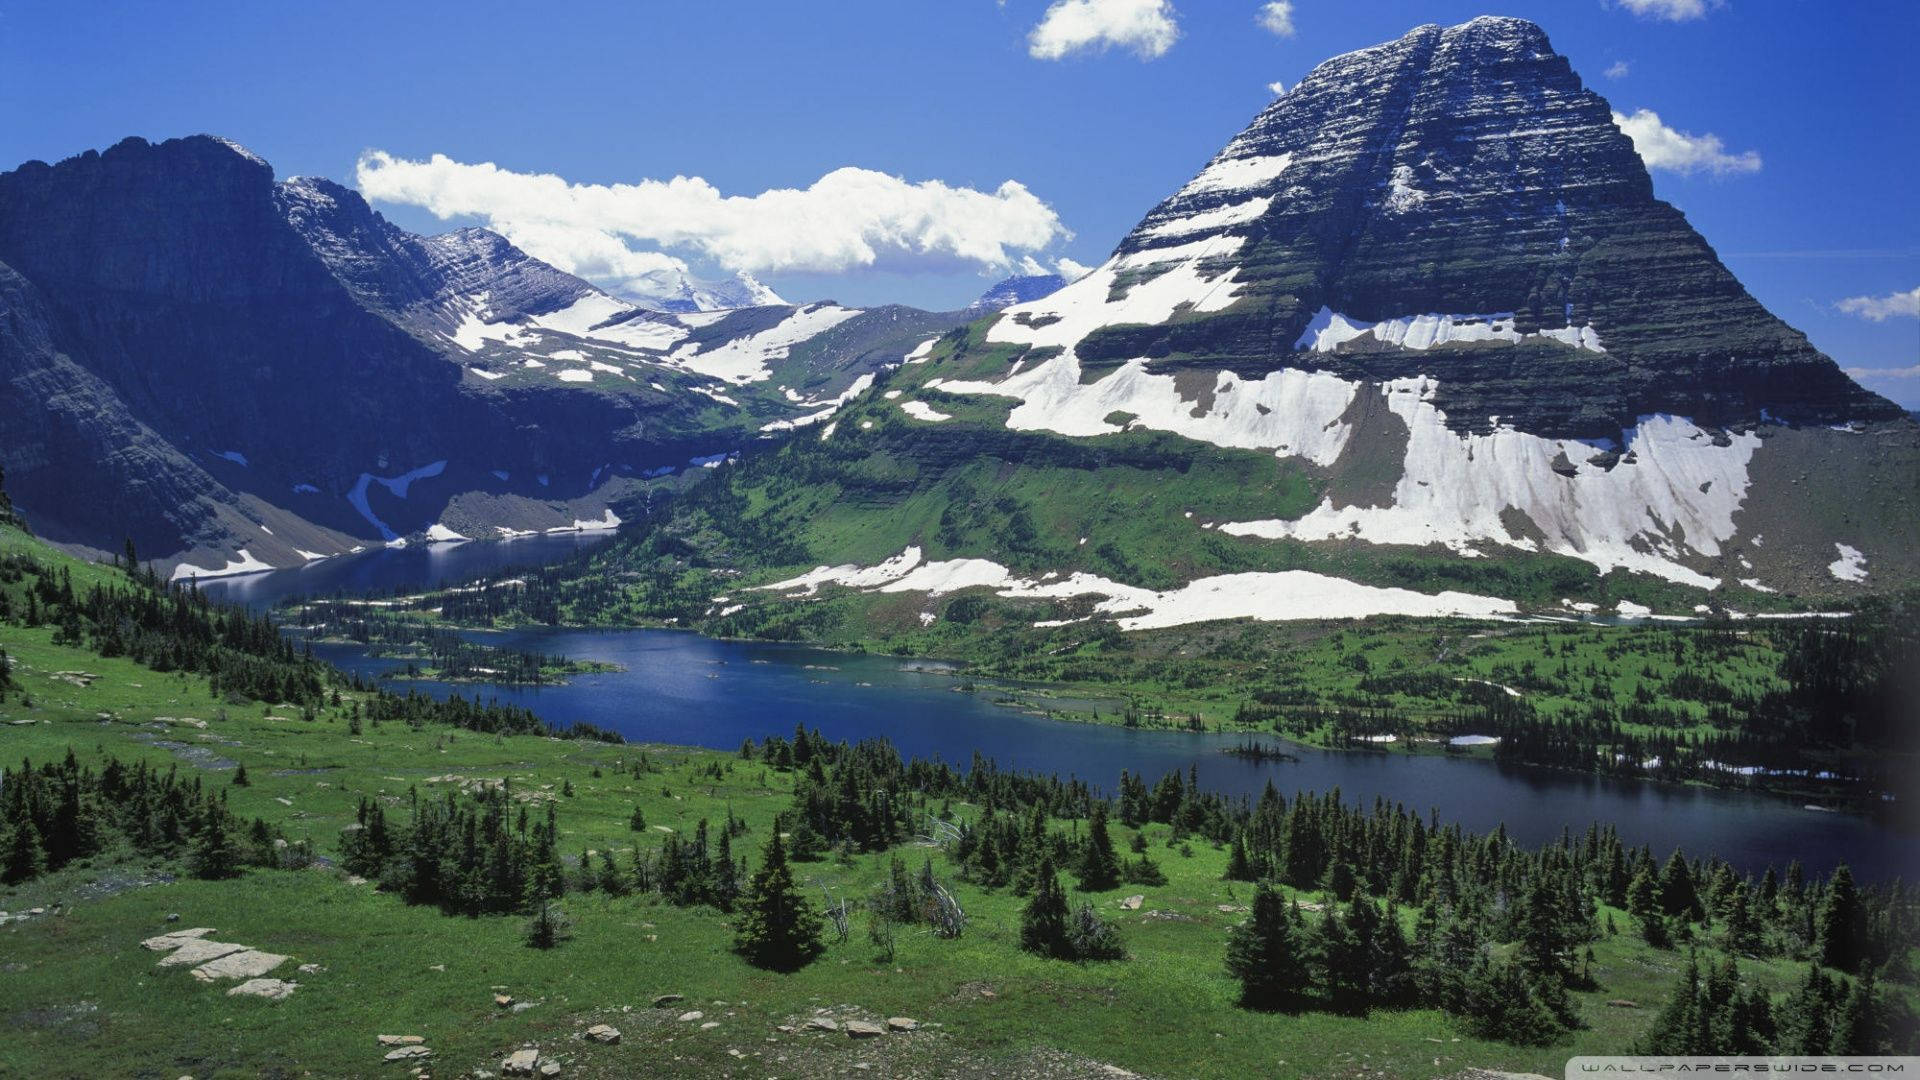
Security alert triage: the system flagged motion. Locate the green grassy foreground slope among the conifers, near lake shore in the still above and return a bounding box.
[0,526,1827,1076]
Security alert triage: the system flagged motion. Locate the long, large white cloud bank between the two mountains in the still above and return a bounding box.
[355,150,1069,288]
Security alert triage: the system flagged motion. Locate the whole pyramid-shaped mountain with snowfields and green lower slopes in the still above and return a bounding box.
[595,17,1920,628]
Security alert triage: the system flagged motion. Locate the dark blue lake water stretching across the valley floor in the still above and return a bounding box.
[209,538,1920,878]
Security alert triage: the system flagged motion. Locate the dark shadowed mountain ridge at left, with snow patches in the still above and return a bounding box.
[0,136,954,569]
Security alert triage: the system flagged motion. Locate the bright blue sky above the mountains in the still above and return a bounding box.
[0,0,1920,407]
